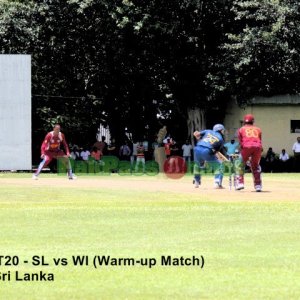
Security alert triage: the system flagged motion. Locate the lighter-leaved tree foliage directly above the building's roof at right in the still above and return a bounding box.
[224,0,300,101]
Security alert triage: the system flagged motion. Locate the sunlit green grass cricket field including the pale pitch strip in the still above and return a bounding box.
[0,173,300,299]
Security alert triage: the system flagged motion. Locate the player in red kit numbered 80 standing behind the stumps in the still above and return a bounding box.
[236,114,262,192]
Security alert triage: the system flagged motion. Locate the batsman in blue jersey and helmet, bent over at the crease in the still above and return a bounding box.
[194,124,225,189]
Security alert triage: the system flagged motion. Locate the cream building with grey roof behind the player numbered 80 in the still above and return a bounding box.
[224,95,300,155]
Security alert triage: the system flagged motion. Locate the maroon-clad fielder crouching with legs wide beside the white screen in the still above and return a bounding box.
[32,124,76,179]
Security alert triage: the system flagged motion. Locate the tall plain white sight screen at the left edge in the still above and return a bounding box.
[0,55,32,170]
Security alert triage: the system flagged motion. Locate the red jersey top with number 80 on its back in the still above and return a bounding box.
[238,124,262,148]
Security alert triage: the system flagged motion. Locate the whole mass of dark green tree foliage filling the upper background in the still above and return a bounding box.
[0,0,300,148]
